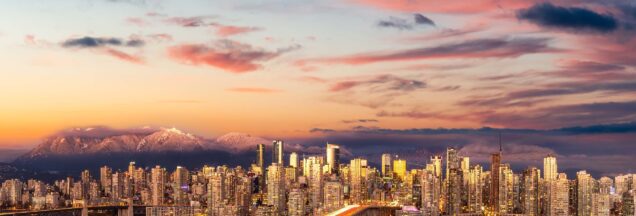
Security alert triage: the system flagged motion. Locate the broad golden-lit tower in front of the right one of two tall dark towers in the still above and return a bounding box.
[267,163,286,215]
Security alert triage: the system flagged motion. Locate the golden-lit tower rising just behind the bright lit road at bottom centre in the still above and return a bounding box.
[349,158,368,204]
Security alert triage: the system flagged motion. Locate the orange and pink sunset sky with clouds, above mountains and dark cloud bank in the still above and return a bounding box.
[0,0,636,153]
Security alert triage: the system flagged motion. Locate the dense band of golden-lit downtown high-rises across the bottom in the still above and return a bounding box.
[0,140,636,216]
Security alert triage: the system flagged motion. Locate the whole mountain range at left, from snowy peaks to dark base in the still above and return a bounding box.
[12,127,271,174]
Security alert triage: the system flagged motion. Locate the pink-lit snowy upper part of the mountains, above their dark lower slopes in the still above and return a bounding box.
[19,127,269,160]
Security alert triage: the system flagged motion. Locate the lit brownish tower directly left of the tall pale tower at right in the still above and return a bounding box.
[521,167,541,216]
